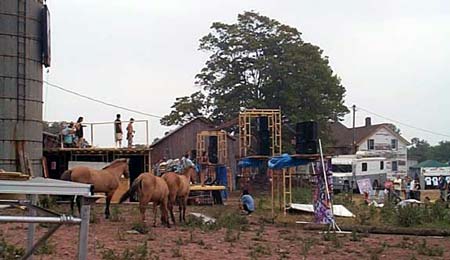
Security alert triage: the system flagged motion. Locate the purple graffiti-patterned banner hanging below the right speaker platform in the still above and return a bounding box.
[313,159,334,224]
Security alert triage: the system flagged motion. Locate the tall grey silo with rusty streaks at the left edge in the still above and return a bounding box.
[0,0,48,176]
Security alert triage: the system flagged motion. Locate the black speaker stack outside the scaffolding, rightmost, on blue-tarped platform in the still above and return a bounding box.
[295,121,319,154]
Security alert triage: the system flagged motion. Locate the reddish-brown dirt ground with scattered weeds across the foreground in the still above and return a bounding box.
[0,192,450,260]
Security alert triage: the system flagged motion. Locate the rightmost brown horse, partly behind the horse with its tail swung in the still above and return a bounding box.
[162,167,195,224]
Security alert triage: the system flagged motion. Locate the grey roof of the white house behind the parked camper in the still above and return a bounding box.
[329,122,409,147]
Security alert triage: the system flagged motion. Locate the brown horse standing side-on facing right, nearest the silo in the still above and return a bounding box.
[61,159,130,219]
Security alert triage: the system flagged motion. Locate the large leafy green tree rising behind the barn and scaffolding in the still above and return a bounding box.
[161,12,348,141]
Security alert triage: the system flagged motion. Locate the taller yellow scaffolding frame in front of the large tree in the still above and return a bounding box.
[239,109,281,158]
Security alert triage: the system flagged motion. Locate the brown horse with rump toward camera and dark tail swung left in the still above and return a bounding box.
[119,172,170,227]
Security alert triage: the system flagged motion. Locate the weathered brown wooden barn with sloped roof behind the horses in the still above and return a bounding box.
[150,117,239,179]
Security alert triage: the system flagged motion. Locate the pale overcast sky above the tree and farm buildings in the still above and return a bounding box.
[44,0,450,146]
